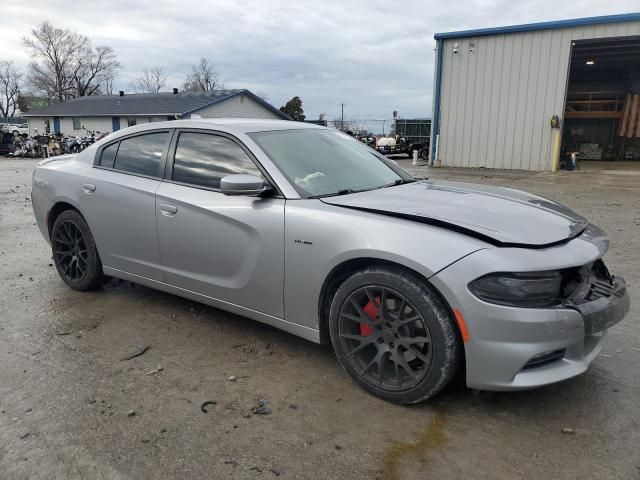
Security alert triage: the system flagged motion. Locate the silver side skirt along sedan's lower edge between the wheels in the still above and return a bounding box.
[102,266,320,343]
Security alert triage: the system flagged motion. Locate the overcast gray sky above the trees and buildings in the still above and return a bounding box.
[0,0,638,130]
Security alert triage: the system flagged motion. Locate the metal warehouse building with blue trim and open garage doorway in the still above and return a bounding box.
[430,13,640,171]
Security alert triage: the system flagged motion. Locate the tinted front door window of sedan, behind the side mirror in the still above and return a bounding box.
[171,132,262,189]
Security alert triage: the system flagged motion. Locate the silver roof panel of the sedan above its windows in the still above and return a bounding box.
[112,118,326,138]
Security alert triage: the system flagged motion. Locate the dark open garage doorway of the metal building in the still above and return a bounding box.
[560,37,640,167]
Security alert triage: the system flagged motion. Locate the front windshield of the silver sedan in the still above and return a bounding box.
[249,129,413,198]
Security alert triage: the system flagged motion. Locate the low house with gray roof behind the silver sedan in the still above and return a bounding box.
[24,88,291,136]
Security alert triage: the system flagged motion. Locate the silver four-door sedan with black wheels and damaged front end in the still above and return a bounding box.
[32,119,629,403]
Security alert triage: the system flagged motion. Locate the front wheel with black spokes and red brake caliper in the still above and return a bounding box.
[329,266,463,404]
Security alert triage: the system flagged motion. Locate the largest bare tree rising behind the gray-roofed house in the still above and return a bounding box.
[22,22,122,101]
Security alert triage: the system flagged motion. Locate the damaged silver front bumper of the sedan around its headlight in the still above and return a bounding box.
[431,234,630,390]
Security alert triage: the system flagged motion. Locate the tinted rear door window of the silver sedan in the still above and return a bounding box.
[113,132,169,177]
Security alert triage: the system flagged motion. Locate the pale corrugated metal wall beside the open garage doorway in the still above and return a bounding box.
[436,22,640,171]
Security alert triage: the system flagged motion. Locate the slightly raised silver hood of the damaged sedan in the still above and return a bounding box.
[322,181,588,248]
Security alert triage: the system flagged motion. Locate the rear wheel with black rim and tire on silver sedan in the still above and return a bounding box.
[51,210,109,291]
